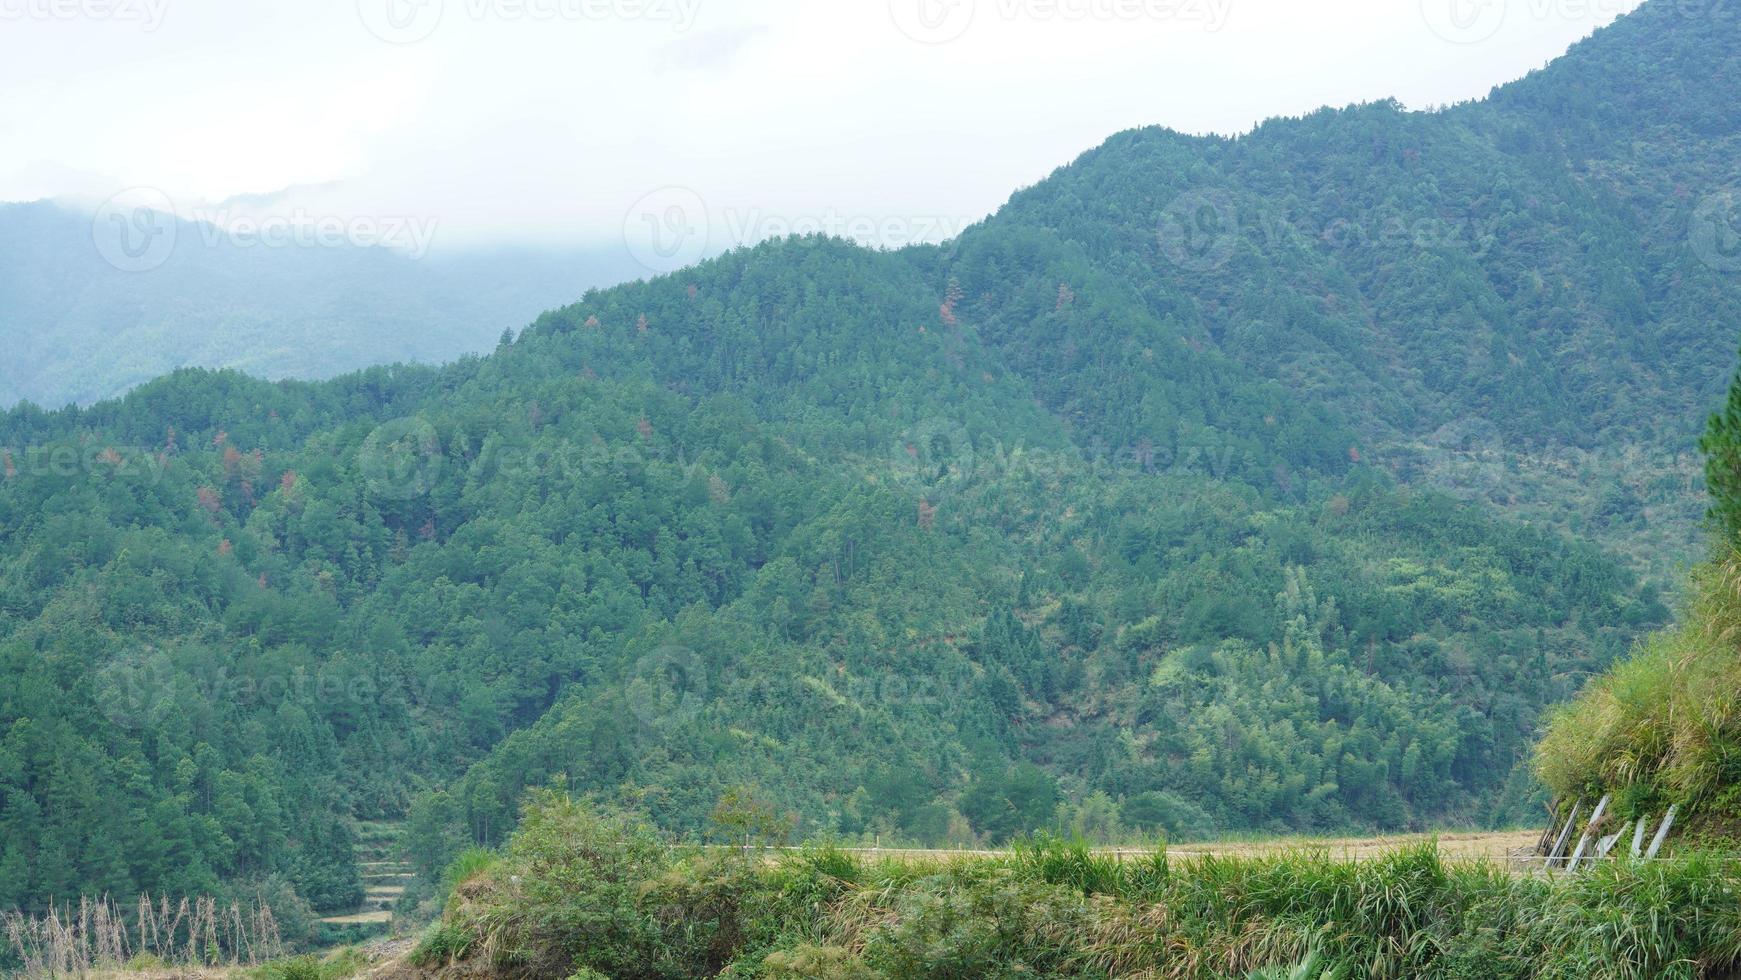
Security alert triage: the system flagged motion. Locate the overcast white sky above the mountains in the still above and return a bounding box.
[0,0,1637,258]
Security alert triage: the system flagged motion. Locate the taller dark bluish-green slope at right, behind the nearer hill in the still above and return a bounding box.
[949,3,1741,574]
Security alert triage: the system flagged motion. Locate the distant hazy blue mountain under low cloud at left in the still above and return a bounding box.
[0,202,637,407]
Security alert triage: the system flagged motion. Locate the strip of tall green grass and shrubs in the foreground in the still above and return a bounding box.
[414,792,1741,980]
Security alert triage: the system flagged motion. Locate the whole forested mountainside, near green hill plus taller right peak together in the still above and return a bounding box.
[0,0,1741,907]
